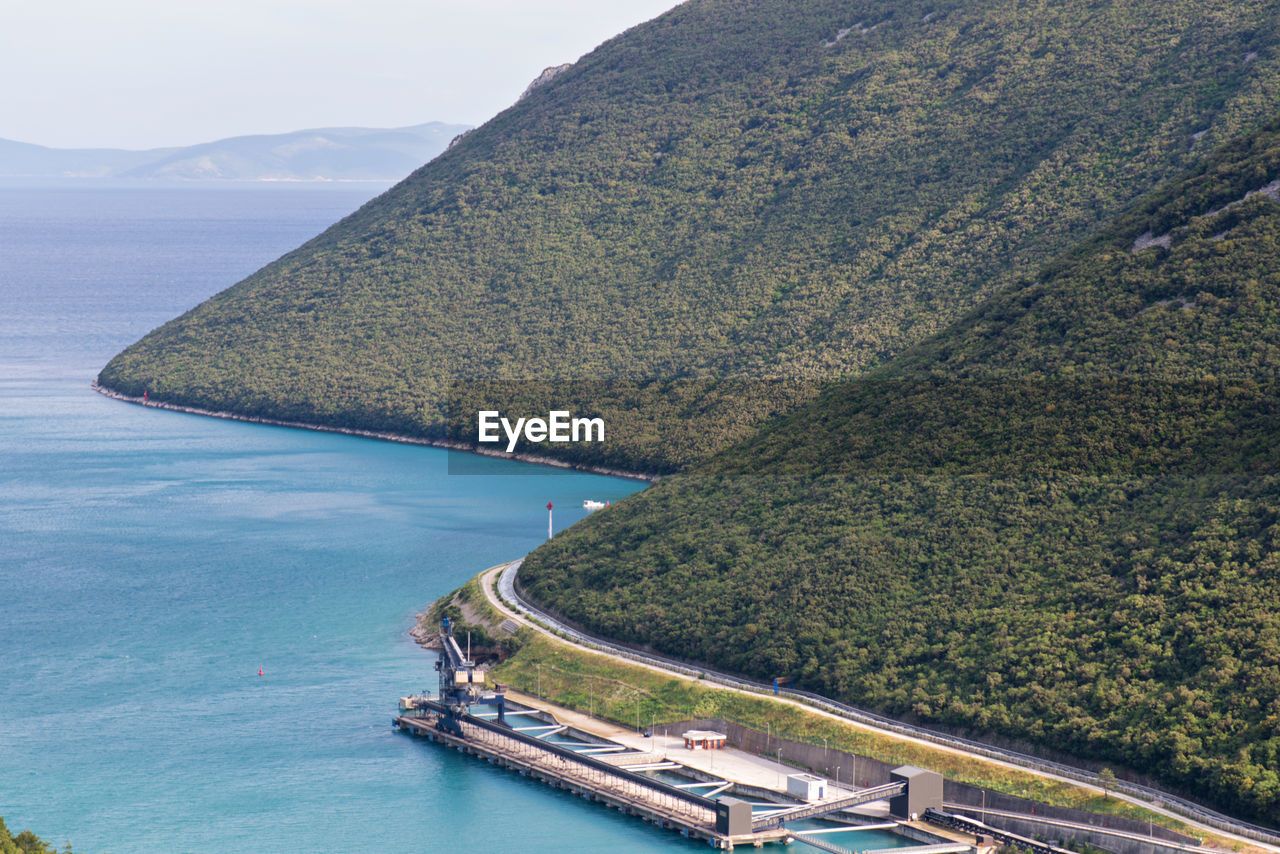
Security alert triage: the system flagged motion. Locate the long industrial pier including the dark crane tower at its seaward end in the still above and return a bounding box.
[393,617,969,854]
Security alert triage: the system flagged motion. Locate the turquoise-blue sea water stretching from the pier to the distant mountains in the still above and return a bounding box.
[0,186,701,854]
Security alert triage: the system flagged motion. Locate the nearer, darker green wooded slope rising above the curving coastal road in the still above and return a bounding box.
[521,119,1280,823]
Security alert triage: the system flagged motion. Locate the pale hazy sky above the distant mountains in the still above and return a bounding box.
[0,0,676,149]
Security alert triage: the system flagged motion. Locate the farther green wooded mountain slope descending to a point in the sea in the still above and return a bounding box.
[100,0,1280,471]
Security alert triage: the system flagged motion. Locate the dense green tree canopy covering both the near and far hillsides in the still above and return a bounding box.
[100,0,1280,822]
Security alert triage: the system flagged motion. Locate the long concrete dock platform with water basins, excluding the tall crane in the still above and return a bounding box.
[393,686,983,854]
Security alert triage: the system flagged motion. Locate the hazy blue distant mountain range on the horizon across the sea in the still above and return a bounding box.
[0,122,468,181]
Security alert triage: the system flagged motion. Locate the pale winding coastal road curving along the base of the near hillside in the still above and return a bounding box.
[480,558,1280,854]
